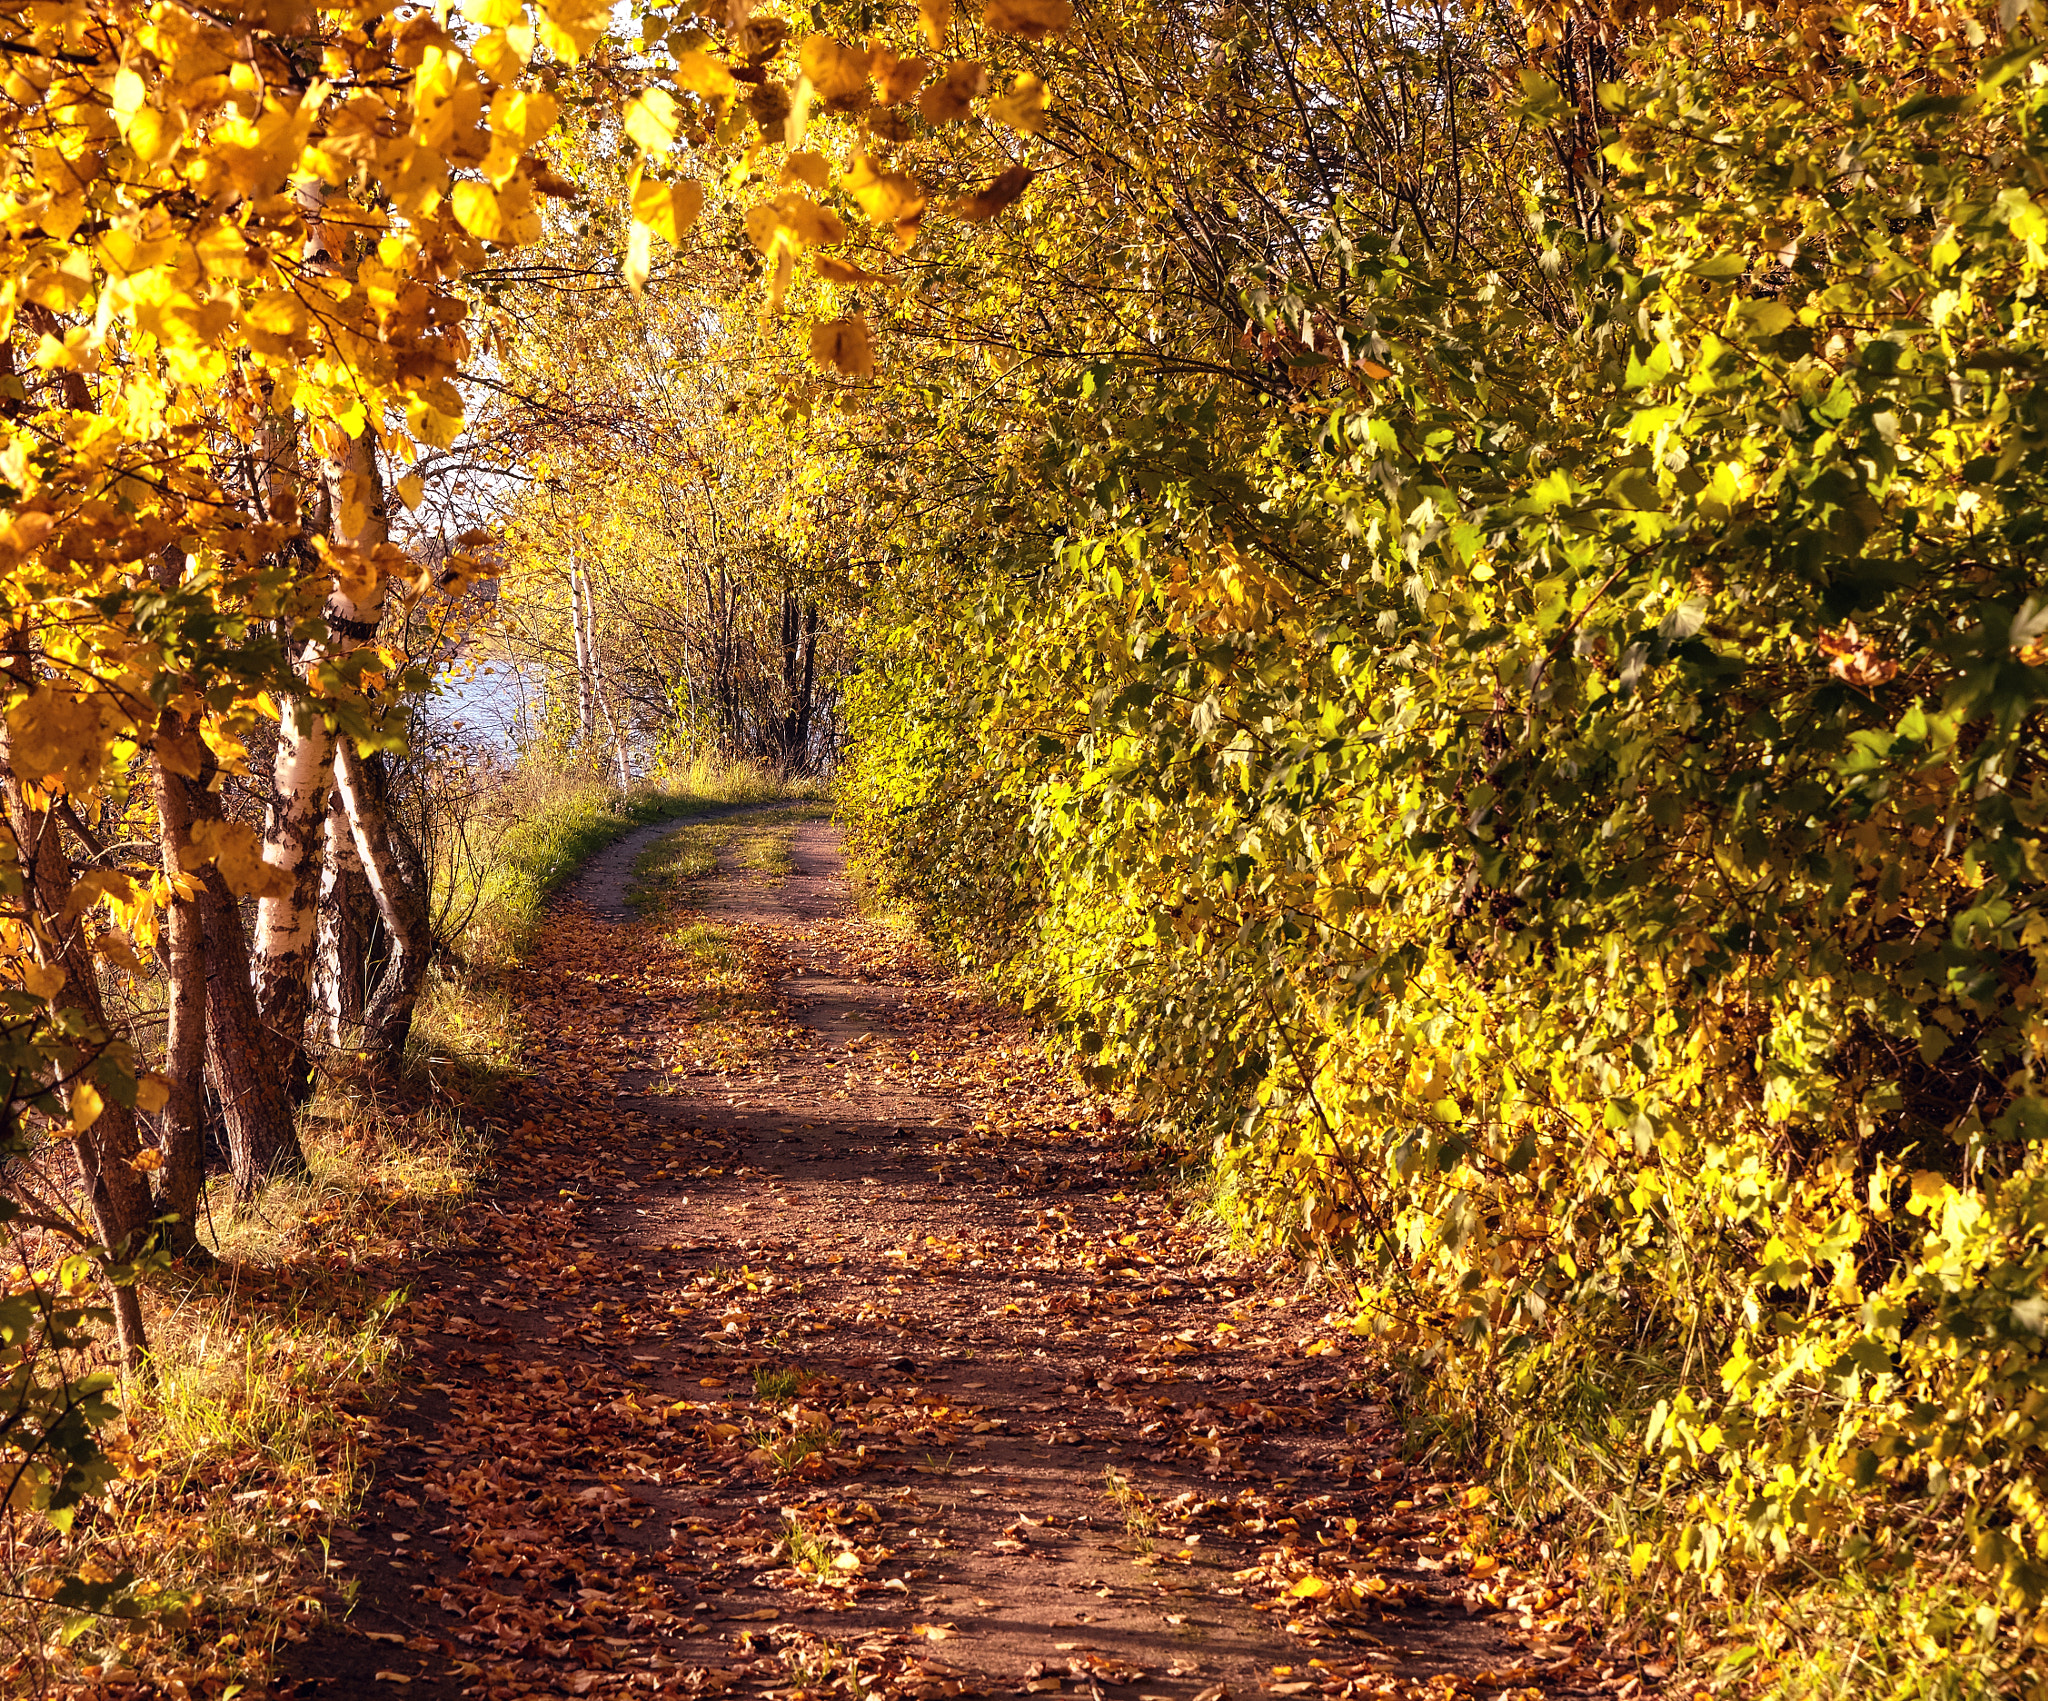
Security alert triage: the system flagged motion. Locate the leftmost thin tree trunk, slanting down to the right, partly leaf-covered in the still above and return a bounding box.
[0,745,154,1376]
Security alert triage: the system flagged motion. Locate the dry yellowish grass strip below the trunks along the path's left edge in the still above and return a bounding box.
[0,998,514,1697]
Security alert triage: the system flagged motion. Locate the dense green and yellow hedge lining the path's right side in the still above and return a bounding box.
[846,8,2048,1693]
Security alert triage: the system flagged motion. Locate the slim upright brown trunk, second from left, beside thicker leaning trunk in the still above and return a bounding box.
[156,710,207,1259]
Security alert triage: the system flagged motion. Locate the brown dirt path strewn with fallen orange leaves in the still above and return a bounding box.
[289,813,1613,1701]
